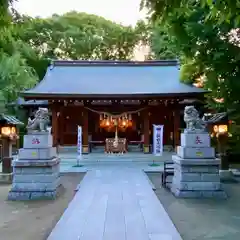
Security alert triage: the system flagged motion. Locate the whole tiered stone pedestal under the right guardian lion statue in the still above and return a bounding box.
[171,133,227,198]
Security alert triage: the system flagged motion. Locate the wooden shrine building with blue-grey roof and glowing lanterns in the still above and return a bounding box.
[23,60,205,153]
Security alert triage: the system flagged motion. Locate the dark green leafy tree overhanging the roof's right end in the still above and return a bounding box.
[141,0,240,154]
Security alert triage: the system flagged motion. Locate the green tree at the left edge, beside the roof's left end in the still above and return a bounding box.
[0,1,39,102]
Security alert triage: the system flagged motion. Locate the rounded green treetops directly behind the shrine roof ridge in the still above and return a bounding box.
[21,12,141,60]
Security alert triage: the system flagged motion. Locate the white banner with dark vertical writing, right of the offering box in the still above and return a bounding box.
[153,124,163,156]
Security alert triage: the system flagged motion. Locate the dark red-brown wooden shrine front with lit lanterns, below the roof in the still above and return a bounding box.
[57,103,179,153]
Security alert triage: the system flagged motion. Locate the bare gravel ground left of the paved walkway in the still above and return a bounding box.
[0,173,84,240]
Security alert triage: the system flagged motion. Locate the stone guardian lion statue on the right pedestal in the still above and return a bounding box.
[184,106,206,132]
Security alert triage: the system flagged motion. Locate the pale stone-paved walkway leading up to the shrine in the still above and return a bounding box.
[48,167,182,240]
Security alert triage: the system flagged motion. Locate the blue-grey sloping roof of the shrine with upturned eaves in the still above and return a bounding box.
[24,60,205,99]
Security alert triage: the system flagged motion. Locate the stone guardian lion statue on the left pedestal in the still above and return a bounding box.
[27,108,49,132]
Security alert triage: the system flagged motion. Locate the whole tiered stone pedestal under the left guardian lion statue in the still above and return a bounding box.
[8,132,60,200]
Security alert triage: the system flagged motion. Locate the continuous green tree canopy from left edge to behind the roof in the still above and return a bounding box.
[0,8,143,104]
